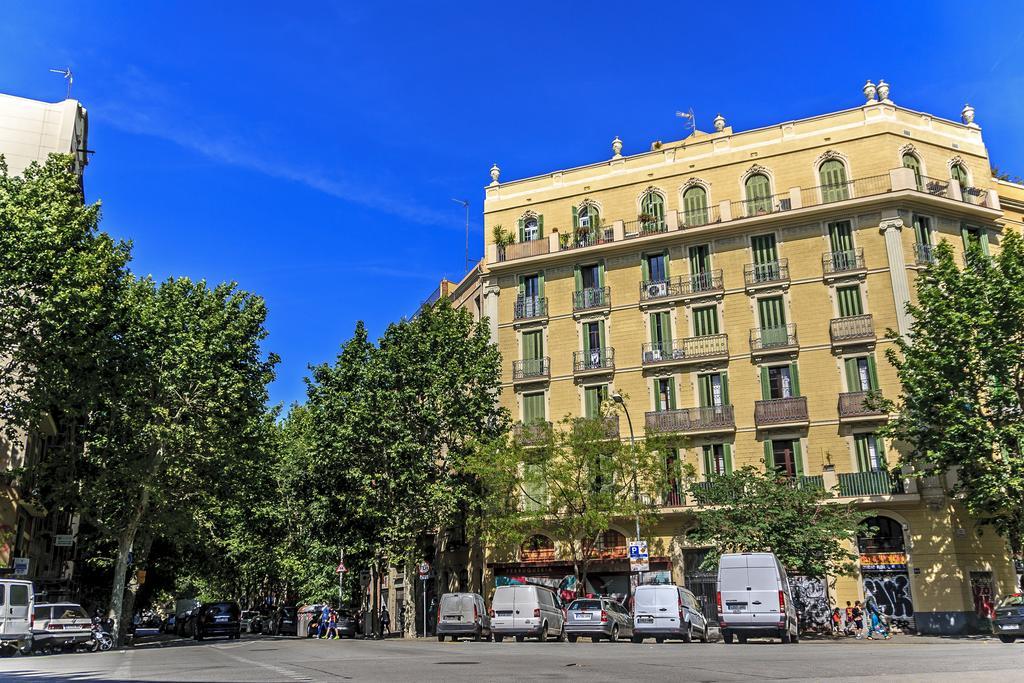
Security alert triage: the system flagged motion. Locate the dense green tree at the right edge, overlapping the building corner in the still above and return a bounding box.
[882,231,1024,551]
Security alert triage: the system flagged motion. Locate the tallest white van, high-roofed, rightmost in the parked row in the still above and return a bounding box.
[718,553,800,643]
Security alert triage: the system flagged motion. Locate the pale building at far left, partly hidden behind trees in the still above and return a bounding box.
[0,93,89,599]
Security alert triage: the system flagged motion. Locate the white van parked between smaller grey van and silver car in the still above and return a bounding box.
[490,586,565,643]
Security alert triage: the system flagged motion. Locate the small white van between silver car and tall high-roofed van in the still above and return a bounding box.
[632,584,708,643]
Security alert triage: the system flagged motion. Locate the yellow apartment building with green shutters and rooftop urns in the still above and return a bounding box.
[482,82,1021,633]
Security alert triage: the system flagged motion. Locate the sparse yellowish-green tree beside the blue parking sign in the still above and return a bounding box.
[468,417,667,590]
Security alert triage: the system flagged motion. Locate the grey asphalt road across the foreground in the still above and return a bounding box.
[0,636,1024,683]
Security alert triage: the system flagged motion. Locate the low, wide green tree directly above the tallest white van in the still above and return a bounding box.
[686,473,870,578]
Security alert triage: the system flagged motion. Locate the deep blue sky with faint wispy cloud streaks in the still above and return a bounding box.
[0,1,1024,403]
